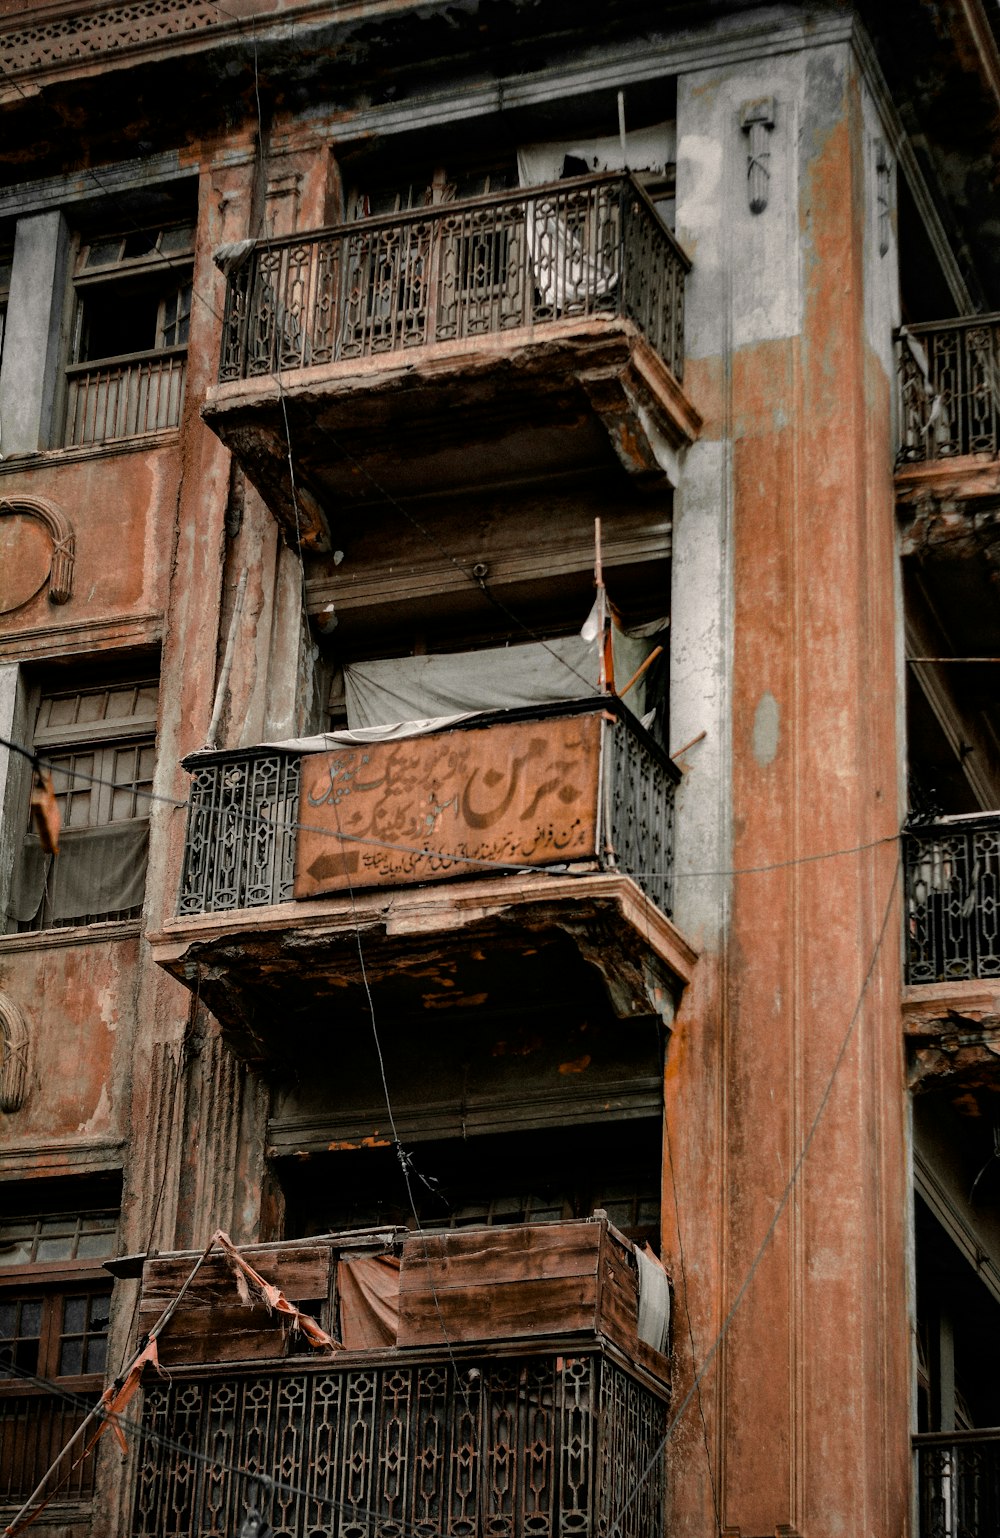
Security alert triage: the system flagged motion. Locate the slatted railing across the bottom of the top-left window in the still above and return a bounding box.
[65,348,186,448]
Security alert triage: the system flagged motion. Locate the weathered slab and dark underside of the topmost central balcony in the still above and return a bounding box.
[203,317,702,551]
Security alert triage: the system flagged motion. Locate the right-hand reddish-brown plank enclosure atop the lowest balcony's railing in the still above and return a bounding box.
[397,1220,638,1352]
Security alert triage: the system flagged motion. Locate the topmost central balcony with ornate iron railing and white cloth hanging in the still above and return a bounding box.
[203,174,700,549]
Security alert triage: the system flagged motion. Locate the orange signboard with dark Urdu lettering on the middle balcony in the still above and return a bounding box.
[295,711,602,898]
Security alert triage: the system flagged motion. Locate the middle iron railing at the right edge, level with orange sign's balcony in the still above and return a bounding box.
[905,814,1000,983]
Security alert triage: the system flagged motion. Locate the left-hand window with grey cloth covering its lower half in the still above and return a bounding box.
[8,678,157,930]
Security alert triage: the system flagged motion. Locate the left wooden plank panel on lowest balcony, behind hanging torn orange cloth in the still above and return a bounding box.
[138,1244,331,1367]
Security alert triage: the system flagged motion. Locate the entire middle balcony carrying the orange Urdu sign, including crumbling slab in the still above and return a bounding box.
[151,697,694,1060]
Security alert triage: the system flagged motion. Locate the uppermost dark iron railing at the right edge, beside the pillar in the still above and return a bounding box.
[898,315,1000,463]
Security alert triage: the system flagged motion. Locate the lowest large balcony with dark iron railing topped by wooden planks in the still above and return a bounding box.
[132,1221,669,1538]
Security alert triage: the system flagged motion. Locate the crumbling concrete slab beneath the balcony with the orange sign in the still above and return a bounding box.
[149,872,697,1061]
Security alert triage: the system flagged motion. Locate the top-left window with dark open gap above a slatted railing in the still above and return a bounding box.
[66,223,194,444]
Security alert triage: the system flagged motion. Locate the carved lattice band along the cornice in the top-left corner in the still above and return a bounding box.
[0,0,220,75]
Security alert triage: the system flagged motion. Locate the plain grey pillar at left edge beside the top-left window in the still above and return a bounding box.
[0,212,69,457]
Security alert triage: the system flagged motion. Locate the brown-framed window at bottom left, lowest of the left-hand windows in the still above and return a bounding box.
[0,1181,117,1512]
